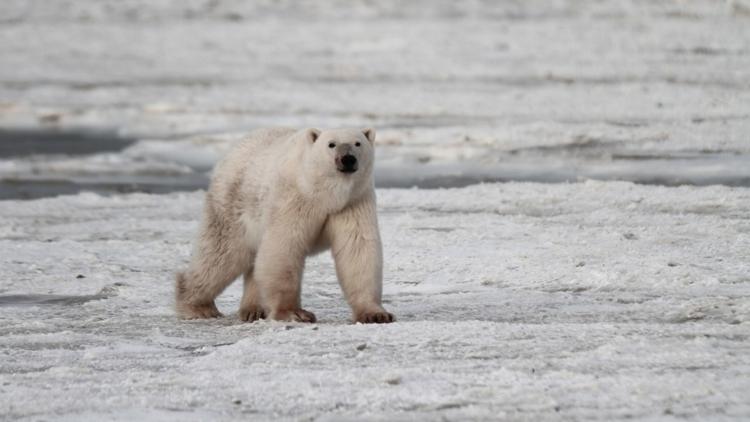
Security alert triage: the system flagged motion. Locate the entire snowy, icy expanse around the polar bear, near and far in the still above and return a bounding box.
[0,0,750,421]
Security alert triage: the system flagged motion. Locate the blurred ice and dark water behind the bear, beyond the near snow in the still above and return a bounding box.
[0,0,750,198]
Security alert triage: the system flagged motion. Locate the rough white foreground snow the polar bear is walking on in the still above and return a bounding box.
[0,182,750,421]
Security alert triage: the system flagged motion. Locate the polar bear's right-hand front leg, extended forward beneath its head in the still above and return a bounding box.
[325,194,395,323]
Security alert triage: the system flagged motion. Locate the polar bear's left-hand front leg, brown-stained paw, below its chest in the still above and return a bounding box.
[254,219,319,322]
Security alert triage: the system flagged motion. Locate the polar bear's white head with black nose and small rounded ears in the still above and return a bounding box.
[304,128,375,179]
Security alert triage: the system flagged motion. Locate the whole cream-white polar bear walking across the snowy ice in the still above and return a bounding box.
[176,128,394,323]
